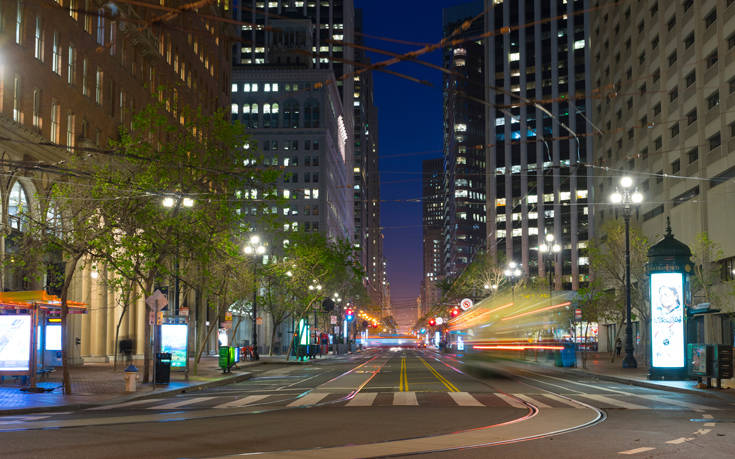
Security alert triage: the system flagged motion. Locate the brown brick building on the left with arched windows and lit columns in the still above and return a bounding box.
[0,0,230,363]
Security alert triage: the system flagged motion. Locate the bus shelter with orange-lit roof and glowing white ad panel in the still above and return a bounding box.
[0,290,87,388]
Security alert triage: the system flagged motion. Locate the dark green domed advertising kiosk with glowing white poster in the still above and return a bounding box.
[646,218,692,379]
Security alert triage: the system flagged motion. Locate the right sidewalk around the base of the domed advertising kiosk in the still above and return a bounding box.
[568,352,735,398]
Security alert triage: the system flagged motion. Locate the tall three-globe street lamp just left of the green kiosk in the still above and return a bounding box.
[610,175,643,368]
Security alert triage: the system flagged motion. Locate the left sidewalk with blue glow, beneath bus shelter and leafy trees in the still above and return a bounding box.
[0,355,339,415]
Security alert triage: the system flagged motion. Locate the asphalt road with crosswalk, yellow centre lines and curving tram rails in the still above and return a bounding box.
[0,350,735,458]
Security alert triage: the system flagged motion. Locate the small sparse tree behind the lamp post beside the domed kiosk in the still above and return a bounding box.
[589,220,650,362]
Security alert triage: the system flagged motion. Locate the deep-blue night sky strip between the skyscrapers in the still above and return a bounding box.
[356,0,467,314]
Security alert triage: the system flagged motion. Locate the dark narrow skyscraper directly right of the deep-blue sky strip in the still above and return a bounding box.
[442,1,485,276]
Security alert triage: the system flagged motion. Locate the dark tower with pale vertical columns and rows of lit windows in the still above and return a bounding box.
[486,0,596,289]
